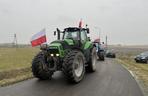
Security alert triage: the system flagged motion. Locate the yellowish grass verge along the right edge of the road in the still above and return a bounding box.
[116,59,148,96]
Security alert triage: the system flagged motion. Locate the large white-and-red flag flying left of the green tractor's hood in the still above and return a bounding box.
[31,29,47,47]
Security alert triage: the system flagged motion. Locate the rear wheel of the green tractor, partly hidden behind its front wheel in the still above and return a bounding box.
[86,47,97,72]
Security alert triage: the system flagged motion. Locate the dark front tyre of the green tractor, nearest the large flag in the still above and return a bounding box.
[32,51,53,80]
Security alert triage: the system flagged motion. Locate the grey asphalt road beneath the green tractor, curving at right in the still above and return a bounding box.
[0,59,143,96]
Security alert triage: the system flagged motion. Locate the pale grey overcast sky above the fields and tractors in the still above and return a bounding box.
[0,0,148,44]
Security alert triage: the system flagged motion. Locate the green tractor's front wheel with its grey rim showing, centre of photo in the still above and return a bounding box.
[63,50,85,83]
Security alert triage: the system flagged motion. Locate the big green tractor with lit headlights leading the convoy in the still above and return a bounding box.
[32,27,97,83]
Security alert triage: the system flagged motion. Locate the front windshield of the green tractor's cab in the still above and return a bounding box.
[63,31,78,39]
